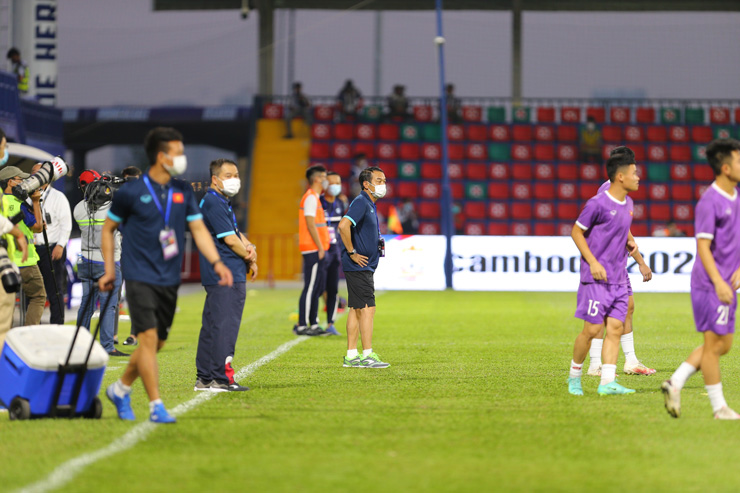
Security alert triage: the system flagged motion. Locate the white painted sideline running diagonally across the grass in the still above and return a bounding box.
[17,336,308,493]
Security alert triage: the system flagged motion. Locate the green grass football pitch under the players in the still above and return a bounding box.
[0,290,740,492]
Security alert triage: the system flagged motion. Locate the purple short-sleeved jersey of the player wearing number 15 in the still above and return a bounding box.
[576,192,633,284]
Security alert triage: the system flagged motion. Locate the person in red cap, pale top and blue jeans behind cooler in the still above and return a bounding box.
[73,170,129,356]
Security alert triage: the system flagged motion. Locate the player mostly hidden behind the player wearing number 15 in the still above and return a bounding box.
[586,146,655,376]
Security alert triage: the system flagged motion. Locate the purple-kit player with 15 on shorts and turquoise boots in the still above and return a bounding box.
[568,153,640,395]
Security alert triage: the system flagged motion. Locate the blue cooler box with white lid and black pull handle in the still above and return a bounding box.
[0,325,108,416]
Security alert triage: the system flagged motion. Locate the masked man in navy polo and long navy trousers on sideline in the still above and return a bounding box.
[194,159,257,392]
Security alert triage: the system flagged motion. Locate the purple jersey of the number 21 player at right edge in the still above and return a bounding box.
[691,183,740,291]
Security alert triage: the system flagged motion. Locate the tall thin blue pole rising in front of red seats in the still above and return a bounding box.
[434,0,455,289]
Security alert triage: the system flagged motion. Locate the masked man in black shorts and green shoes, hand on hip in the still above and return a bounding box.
[339,166,391,368]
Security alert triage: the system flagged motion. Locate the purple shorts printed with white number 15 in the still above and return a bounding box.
[575,283,629,324]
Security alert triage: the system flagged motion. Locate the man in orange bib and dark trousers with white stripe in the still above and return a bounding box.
[293,166,329,336]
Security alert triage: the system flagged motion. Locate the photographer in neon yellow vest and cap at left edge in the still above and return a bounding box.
[0,166,46,325]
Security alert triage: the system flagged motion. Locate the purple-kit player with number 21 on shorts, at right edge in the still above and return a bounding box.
[661,139,740,419]
